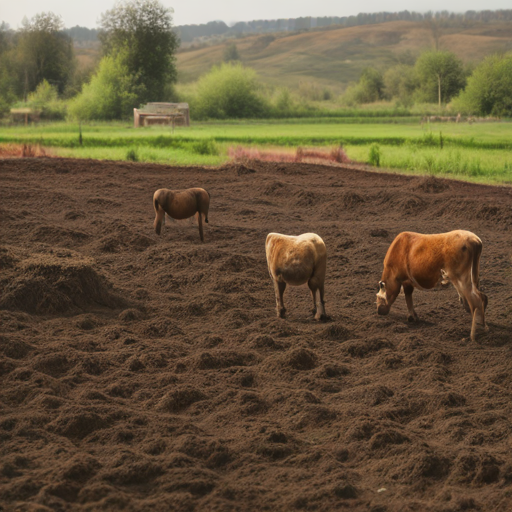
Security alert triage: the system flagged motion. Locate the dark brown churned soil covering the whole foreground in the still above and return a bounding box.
[0,159,512,512]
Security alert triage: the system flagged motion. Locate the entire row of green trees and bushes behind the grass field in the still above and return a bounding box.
[0,0,512,120]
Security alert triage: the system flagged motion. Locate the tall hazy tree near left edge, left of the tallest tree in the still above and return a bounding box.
[17,12,75,96]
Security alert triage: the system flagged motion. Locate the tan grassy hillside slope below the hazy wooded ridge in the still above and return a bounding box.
[177,21,512,89]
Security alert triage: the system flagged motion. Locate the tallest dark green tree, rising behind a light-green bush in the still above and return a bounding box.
[99,0,179,102]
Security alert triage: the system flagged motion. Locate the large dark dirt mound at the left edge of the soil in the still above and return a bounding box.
[0,252,127,315]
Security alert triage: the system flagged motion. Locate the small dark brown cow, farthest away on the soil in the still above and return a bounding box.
[153,188,210,242]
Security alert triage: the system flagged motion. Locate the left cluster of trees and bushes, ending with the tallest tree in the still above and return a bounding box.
[0,0,179,119]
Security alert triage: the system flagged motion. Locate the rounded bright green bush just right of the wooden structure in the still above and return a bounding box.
[192,63,267,119]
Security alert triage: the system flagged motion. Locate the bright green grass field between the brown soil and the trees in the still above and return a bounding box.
[0,118,512,184]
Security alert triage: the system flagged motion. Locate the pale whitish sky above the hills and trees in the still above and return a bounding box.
[0,0,512,29]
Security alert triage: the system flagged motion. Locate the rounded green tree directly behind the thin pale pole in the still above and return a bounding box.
[415,50,466,106]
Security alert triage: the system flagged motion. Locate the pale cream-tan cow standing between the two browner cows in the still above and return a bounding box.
[265,233,327,320]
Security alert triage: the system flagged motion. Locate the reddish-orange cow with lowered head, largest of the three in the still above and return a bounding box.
[377,230,487,341]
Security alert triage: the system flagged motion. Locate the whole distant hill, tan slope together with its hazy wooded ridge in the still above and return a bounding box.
[65,9,512,92]
